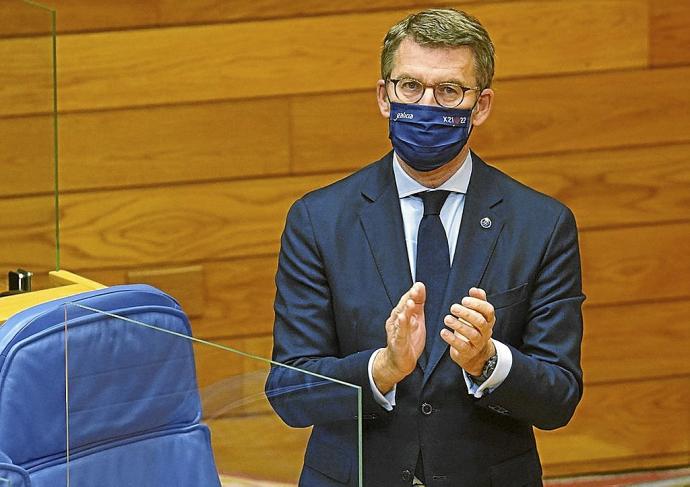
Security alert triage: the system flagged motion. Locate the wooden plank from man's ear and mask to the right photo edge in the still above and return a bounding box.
[474,68,690,156]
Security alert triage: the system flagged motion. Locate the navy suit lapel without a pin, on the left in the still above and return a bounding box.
[360,152,412,308]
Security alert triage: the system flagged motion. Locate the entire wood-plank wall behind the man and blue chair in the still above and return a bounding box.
[0,0,690,483]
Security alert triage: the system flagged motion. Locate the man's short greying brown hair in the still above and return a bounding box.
[381,8,494,89]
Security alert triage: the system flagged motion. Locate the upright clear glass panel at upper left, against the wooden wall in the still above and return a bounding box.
[0,0,59,298]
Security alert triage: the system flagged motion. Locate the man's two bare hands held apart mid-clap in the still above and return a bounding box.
[373,282,496,394]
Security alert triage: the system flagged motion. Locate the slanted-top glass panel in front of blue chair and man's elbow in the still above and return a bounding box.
[65,302,362,487]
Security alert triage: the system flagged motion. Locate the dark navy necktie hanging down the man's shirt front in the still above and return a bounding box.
[416,191,450,358]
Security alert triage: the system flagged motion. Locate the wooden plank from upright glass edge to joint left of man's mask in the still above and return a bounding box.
[55,99,290,191]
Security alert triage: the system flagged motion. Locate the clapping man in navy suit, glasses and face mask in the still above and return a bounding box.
[267,9,584,487]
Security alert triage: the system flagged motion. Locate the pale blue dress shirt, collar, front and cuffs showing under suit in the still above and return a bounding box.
[369,152,513,411]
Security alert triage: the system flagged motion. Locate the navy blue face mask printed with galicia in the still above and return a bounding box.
[389,102,474,172]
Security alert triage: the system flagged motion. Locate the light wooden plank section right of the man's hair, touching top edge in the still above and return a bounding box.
[478,0,649,79]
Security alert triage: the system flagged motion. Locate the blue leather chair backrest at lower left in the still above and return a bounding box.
[0,285,220,487]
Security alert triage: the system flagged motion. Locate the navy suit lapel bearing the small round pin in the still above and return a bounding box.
[424,154,504,383]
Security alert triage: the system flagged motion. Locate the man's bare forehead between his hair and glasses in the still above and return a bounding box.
[392,37,476,84]
